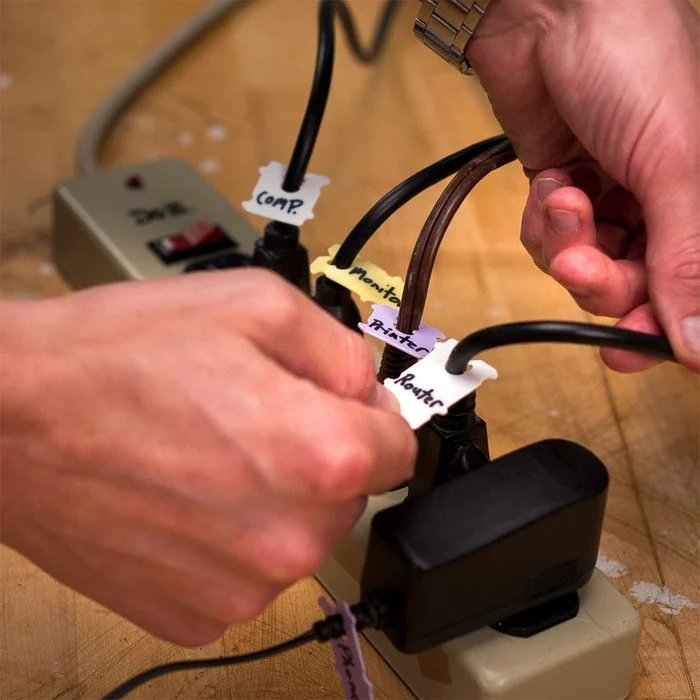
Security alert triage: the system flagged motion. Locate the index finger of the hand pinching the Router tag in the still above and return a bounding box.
[238,273,378,405]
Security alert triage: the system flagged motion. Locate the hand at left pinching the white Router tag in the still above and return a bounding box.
[0,270,415,645]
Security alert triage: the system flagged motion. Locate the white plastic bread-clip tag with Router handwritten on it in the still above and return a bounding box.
[384,338,498,430]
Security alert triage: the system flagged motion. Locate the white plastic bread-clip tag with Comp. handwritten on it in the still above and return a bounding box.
[242,160,330,225]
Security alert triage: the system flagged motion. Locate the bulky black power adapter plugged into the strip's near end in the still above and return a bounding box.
[361,440,608,653]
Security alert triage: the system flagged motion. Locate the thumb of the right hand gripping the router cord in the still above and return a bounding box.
[645,183,700,372]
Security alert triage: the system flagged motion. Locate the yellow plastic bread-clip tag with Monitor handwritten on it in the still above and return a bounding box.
[311,244,403,309]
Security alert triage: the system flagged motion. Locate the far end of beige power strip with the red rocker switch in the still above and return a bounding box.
[53,159,259,289]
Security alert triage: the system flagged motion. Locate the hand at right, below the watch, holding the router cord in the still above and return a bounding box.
[467,0,700,372]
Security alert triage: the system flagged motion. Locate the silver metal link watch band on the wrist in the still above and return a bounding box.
[413,0,491,75]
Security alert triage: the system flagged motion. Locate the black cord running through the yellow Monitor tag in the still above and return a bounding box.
[333,135,508,270]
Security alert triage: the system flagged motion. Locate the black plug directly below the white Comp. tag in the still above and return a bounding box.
[251,221,311,294]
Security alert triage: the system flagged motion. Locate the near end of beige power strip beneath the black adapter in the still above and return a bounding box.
[317,489,641,700]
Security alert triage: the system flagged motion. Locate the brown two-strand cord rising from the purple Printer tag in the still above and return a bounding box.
[396,140,516,333]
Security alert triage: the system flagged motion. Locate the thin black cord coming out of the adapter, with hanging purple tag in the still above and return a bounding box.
[105,595,388,700]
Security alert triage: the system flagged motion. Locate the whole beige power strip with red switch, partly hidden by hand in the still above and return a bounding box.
[53,159,641,700]
